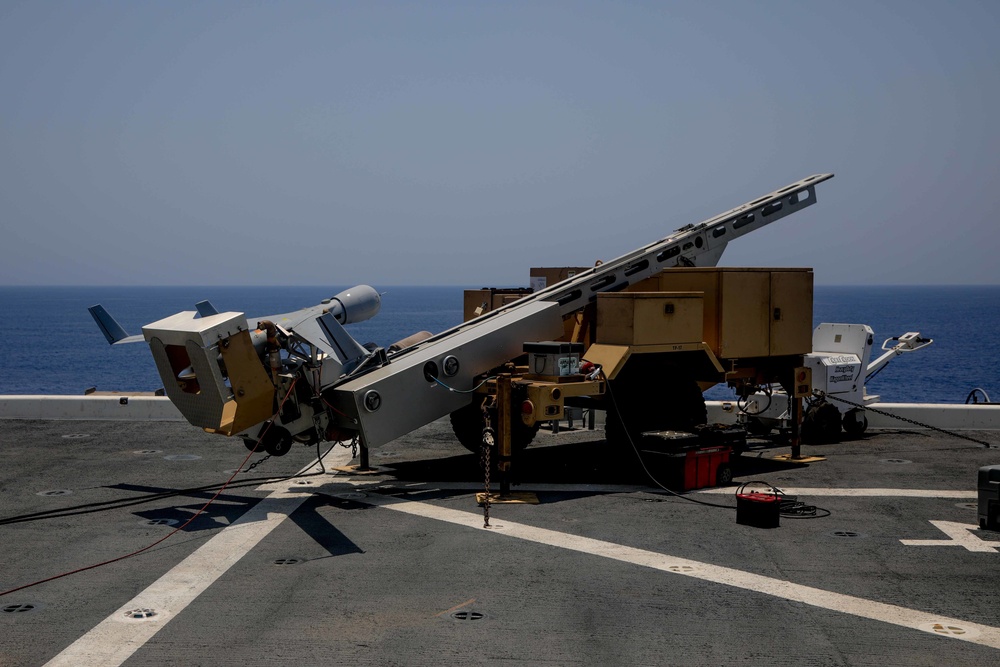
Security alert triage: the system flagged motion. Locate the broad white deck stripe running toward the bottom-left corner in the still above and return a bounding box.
[46,447,351,667]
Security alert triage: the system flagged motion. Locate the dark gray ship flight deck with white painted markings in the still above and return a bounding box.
[0,420,1000,667]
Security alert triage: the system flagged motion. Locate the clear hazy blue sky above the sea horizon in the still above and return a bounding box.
[0,0,1000,285]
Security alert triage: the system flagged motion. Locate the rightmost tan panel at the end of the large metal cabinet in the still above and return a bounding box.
[770,270,813,356]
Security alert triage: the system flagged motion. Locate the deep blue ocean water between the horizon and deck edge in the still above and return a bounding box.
[0,286,1000,403]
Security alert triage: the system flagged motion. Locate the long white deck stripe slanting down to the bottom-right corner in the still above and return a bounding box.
[370,494,1000,649]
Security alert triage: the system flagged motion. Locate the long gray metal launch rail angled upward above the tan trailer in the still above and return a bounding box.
[331,174,833,447]
